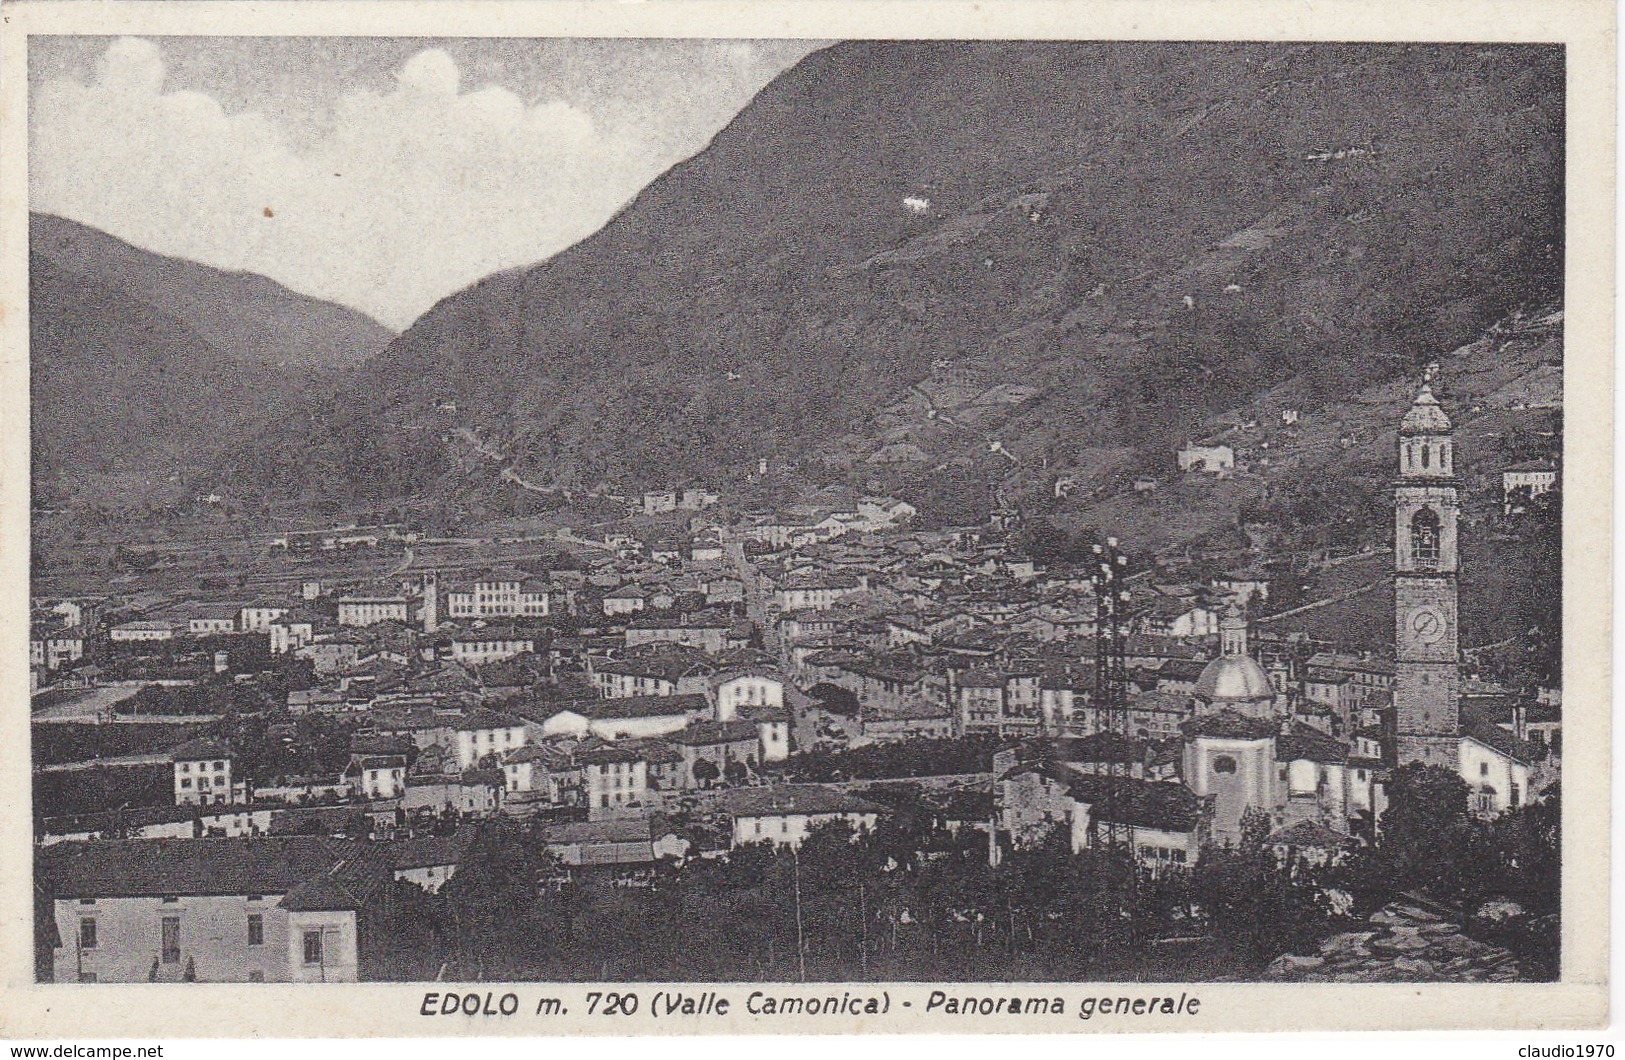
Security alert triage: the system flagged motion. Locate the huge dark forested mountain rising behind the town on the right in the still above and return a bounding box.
[310,42,1563,519]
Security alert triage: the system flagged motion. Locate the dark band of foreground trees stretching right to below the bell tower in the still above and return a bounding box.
[371,766,1560,982]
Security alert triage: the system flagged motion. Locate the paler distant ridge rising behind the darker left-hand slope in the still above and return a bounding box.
[28,213,395,369]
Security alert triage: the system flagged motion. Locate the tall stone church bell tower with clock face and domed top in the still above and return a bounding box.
[1394,384,1461,771]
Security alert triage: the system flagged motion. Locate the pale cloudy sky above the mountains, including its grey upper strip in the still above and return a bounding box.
[29,37,819,328]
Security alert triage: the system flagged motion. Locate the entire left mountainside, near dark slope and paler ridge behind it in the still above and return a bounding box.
[29,215,390,512]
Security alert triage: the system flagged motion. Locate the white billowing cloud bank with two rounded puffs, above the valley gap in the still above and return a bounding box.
[29,37,676,327]
